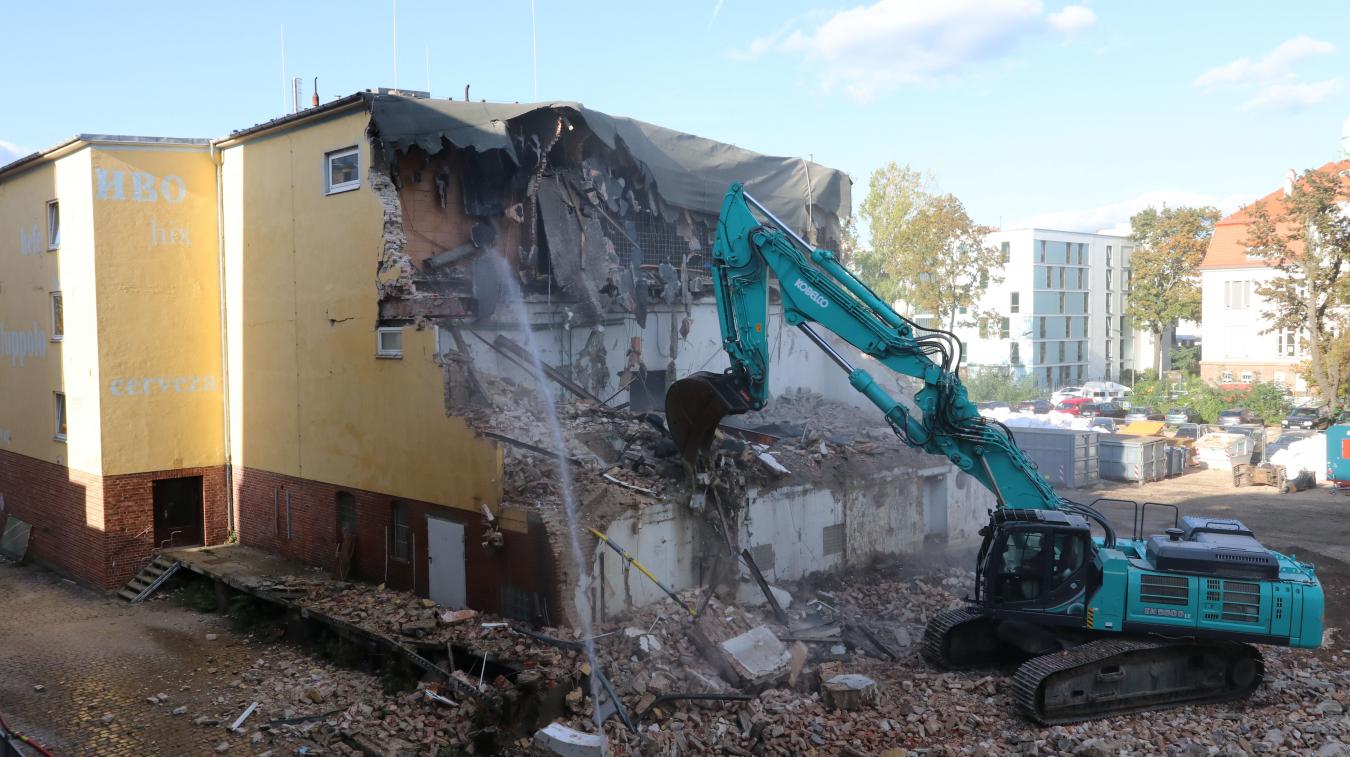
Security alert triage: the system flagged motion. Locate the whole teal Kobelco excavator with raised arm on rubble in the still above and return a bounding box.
[666,185,1323,723]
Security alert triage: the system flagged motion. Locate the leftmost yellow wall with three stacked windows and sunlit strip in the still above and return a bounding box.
[0,148,101,472]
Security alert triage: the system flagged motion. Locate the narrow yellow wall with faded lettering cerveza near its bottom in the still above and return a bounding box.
[90,144,224,475]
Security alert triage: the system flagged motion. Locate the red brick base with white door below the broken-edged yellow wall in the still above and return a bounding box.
[234,467,562,622]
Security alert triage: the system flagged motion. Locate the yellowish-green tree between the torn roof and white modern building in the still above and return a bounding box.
[853,162,1002,328]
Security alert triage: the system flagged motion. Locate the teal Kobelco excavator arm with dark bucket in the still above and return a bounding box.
[666,184,1061,510]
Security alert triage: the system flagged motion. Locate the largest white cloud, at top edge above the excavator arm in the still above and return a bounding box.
[743,0,1096,100]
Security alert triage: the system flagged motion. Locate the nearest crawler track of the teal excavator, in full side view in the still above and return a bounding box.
[1013,638,1265,725]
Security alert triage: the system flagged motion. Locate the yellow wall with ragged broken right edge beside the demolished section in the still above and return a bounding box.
[221,109,501,509]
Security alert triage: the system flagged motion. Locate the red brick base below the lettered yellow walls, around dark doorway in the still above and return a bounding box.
[0,449,227,588]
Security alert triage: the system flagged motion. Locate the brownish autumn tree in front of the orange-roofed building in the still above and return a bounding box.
[1246,169,1350,402]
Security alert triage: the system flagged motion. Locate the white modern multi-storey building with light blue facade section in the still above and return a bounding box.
[957,228,1166,389]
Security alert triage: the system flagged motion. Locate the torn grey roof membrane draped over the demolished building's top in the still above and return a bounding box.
[370,94,853,236]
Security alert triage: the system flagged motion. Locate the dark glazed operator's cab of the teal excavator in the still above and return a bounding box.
[981,510,1092,615]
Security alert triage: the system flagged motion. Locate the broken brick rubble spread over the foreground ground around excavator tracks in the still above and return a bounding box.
[174,558,1350,757]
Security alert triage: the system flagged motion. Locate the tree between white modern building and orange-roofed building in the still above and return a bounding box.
[1126,206,1219,374]
